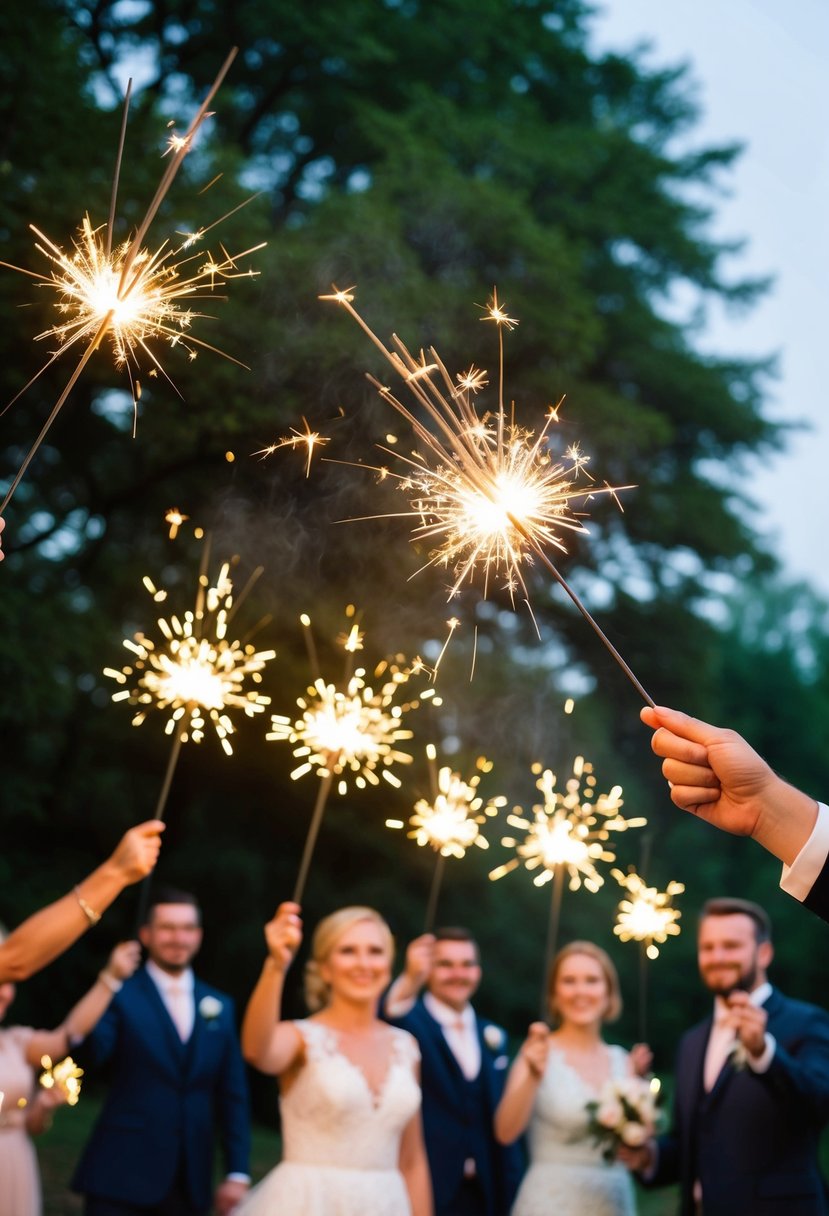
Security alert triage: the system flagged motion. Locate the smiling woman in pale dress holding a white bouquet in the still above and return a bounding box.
[495,941,650,1216]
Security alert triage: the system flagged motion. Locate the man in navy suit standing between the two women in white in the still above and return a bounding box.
[385,929,523,1216]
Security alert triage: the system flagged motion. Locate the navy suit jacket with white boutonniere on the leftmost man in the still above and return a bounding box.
[72,968,250,1211]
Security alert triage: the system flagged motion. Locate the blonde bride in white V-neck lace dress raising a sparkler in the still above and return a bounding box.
[235,903,432,1216]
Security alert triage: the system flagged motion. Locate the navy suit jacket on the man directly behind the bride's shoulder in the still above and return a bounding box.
[393,1000,524,1216]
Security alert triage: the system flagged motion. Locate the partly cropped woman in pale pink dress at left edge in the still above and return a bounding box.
[0,931,141,1216]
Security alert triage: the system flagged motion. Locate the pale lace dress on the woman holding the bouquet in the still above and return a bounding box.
[512,1047,636,1216]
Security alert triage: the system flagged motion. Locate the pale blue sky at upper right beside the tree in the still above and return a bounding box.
[594,0,829,595]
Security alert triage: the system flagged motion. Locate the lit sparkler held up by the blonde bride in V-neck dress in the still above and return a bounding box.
[265,607,438,903]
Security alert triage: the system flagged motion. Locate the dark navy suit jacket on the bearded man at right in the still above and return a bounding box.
[652,990,829,1216]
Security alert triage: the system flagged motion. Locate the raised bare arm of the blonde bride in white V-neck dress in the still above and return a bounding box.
[242,903,303,1076]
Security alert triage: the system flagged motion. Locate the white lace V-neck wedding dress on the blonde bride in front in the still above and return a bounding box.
[233,1020,421,1216]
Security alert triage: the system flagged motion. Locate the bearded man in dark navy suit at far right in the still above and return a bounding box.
[622,899,829,1216]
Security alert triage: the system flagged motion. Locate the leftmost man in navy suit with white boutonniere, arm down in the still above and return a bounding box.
[73,890,250,1216]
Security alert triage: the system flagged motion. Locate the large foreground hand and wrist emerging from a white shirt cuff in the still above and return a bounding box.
[641,705,818,866]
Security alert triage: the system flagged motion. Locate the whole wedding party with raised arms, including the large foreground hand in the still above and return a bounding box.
[0,709,829,1216]
